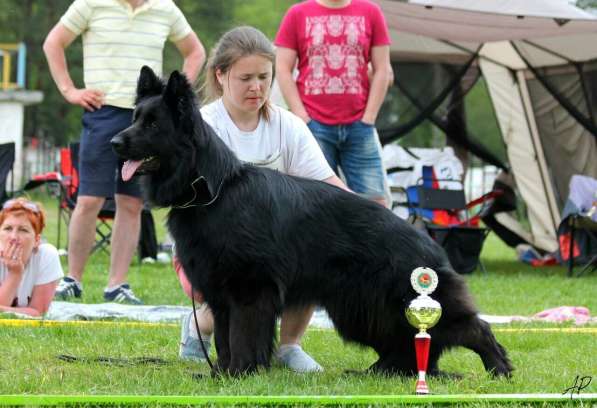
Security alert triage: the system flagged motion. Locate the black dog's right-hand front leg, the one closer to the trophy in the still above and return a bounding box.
[228,297,276,375]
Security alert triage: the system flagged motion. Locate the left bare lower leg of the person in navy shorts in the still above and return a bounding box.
[68,196,105,282]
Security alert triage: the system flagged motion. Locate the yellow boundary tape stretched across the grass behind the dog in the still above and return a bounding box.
[0,319,597,334]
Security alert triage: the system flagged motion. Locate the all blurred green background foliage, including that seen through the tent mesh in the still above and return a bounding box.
[0,0,503,163]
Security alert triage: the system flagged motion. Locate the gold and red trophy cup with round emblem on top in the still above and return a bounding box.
[406,267,442,394]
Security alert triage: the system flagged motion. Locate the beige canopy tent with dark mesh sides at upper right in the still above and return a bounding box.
[376,0,597,251]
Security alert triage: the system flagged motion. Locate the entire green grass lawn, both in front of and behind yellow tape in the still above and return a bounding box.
[0,192,597,406]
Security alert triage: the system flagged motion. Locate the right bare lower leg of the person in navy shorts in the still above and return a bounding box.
[108,194,143,287]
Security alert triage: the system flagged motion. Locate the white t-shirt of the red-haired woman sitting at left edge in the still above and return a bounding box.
[0,244,64,307]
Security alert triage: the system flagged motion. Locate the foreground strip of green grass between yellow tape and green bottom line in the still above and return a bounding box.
[0,326,597,395]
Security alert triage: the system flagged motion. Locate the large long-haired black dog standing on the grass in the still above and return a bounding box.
[112,67,512,375]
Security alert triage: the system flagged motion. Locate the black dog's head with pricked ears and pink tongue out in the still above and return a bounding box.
[111,66,196,181]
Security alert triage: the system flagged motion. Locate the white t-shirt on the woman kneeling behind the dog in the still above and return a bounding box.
[201,98,334,180]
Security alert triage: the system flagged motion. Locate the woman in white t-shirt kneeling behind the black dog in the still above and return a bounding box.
[174,27,346,372]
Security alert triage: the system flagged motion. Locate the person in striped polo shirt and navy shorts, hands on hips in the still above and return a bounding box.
[43,0,205,304]
